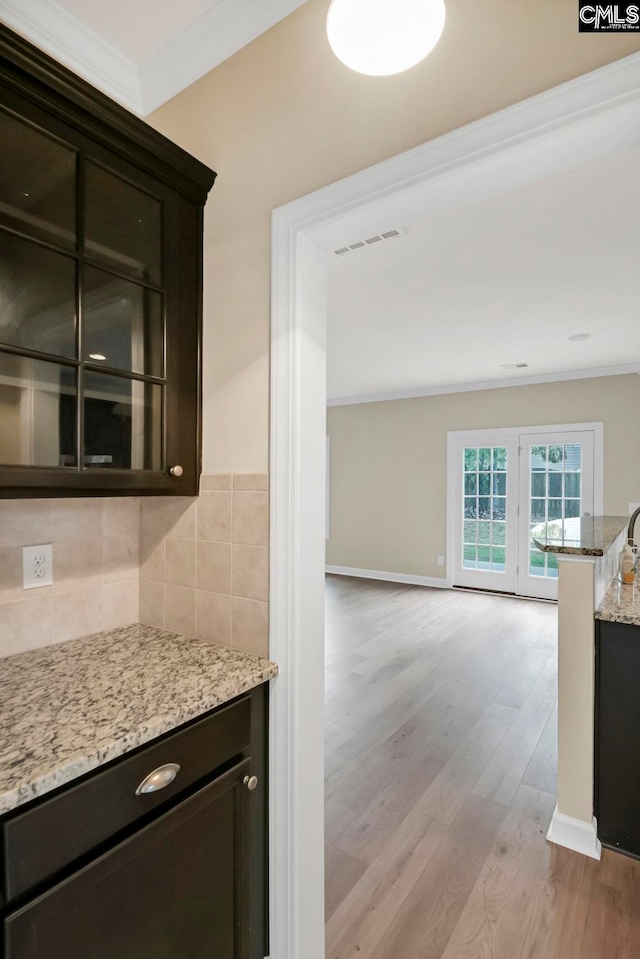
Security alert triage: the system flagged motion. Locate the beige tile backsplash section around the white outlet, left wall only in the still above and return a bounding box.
[0,497,140,656]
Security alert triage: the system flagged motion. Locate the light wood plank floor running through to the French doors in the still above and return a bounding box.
[326,577,640,959]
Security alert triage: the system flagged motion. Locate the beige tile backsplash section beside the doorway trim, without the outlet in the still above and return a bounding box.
[140,473,269,655]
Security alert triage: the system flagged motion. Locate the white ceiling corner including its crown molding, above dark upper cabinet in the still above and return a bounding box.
[0,0,306,116]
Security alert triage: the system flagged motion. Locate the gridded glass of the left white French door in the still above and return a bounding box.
[462,446,507,573]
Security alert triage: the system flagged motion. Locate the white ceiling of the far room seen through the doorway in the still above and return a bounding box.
[328,150,640,400]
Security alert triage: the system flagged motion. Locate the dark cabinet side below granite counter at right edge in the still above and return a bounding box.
[595,621,640,857]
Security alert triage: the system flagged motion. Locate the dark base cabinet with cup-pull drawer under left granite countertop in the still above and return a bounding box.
[3,687,268,959]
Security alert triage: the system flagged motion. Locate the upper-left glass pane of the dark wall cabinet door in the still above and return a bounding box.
[0,110,76,248]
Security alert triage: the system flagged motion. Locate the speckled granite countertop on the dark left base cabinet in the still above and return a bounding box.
[0,626,278,813]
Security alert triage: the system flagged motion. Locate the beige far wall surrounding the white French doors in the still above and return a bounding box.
[327,374,640,577]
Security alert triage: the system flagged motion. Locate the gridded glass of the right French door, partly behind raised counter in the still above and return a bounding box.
[529,443,582,579]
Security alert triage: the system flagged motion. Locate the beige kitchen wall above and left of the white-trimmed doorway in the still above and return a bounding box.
[149,0,640,472]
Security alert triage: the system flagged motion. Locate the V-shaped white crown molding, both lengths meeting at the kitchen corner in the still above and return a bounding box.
[0,0,306,117]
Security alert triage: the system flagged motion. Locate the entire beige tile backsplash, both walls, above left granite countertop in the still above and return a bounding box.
[0,473,269,657]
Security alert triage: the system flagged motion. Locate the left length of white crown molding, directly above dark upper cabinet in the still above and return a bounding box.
[0,0,143,114]
